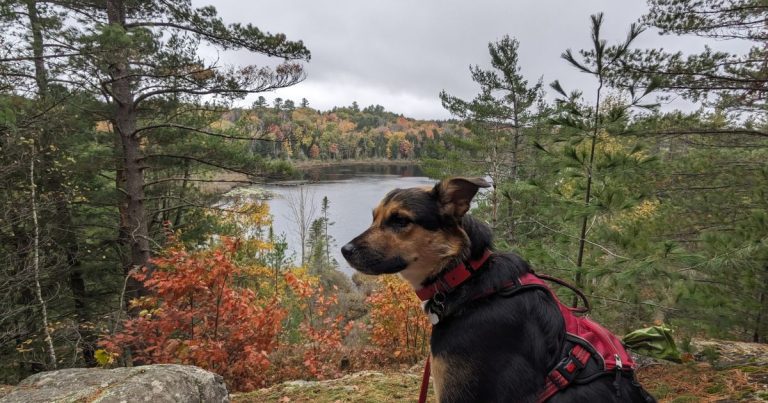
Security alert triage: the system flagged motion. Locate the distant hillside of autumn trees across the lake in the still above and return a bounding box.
[215,101,467,160]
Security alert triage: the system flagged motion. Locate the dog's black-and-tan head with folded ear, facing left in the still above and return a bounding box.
[341,178,490,288]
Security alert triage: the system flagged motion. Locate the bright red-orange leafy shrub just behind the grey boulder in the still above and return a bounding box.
[102,239,285,390]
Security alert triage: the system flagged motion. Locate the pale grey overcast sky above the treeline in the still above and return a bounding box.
[193,0,732,119]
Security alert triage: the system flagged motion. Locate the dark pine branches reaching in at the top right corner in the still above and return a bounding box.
[628,0,768,118]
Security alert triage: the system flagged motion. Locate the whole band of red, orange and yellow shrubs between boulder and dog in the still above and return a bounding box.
[97,203,429,391]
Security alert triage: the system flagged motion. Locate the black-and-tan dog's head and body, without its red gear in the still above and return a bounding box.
[342,178,655,403]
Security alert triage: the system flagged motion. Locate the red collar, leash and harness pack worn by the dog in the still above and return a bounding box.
[416,251,635,403]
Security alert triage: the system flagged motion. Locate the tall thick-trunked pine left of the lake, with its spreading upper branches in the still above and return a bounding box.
[65,0,309,300]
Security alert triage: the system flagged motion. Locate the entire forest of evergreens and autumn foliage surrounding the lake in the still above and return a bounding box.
[0,0,768,400]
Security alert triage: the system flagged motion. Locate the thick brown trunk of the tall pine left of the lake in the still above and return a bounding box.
[107,0,150,299]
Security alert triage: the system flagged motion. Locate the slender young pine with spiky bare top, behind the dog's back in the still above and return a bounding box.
[534,14,653,312]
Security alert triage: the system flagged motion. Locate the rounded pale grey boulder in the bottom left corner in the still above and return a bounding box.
[0,364,229,403]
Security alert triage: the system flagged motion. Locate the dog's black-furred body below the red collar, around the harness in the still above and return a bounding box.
[431,253,653,402]
